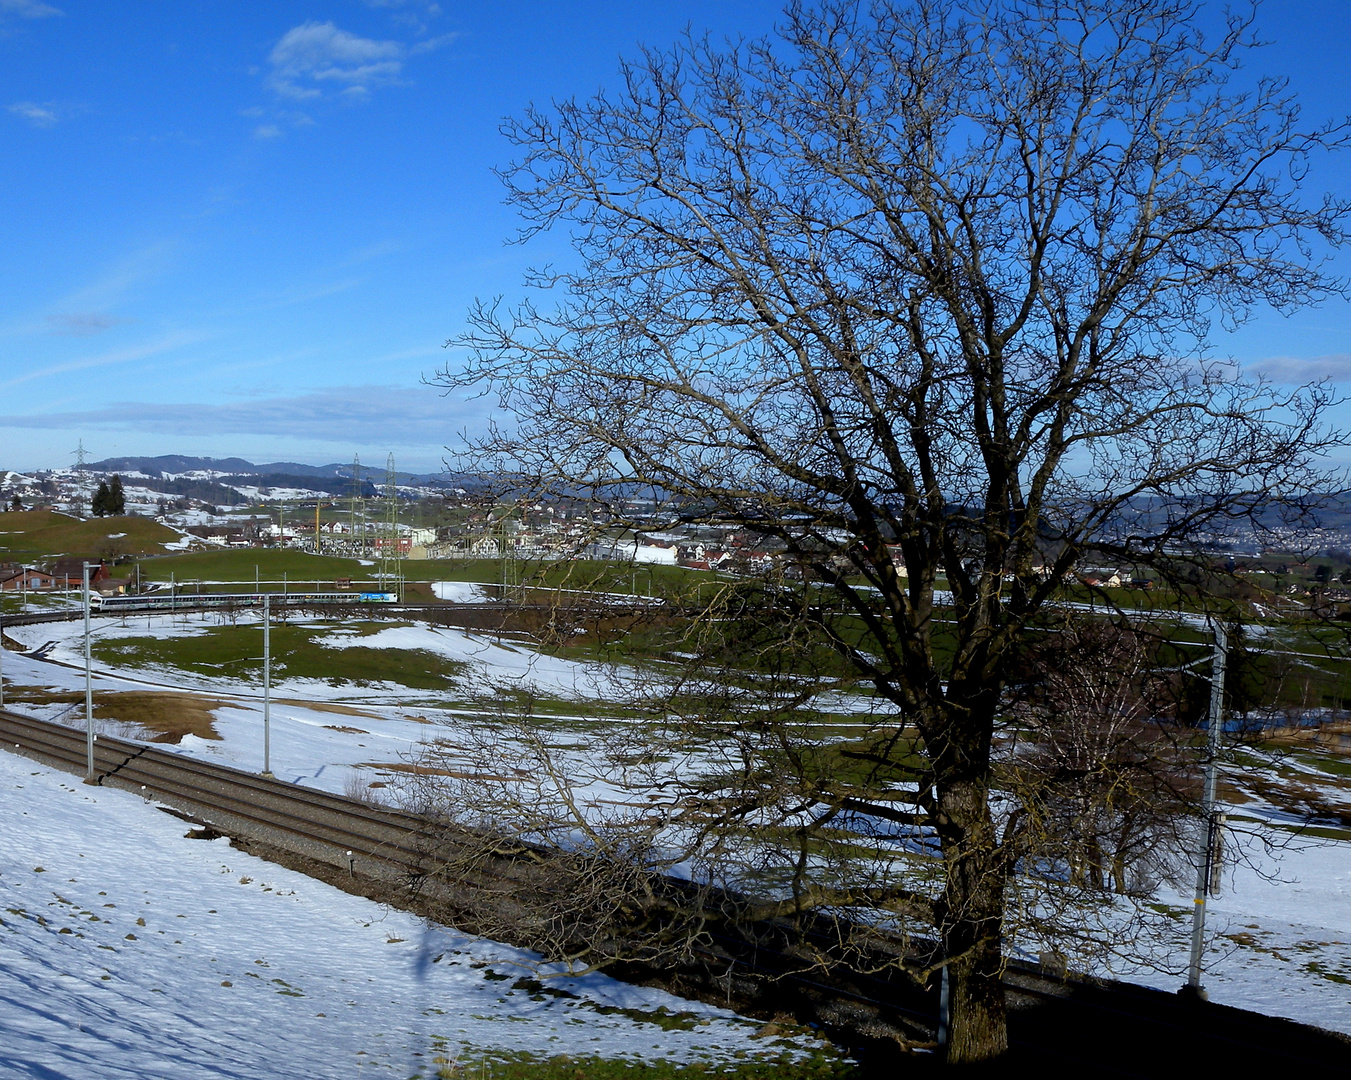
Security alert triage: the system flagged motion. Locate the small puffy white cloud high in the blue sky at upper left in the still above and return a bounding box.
[267,22,407,100]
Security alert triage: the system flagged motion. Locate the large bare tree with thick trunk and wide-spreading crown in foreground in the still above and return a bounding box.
[440,0,1347,1061]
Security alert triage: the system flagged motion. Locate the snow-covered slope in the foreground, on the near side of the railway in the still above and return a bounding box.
[0,754,815,1080]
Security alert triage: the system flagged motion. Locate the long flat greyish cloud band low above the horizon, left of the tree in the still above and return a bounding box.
[0,385,463,447]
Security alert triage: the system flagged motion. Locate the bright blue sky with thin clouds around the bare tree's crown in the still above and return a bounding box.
[0,0,1351,469]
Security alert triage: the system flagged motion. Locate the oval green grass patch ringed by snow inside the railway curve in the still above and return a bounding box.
[93,623,465,691]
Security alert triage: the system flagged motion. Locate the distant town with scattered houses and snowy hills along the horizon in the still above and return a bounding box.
[0,456,1351,616]
